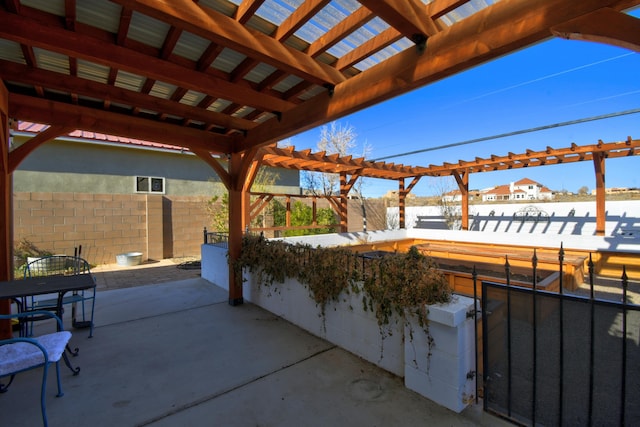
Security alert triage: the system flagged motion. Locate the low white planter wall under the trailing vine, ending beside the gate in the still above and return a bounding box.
[202,245,475,412]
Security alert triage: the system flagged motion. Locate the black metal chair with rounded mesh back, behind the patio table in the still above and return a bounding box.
[22,255,96,338]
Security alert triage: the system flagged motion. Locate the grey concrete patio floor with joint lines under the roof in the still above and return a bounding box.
[0,271,510,427]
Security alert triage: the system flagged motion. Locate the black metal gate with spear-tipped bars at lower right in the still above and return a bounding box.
[482,264,640,426]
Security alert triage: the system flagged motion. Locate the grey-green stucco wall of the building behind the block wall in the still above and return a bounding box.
[13,137,299,197]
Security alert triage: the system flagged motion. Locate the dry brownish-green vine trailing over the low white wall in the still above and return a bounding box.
[234,236,451,330]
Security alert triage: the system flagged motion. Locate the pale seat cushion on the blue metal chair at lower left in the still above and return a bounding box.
[0,331,71,377]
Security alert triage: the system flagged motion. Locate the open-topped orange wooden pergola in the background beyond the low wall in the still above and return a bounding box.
[250,137,640,235]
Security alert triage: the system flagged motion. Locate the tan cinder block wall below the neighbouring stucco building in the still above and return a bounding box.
[13,193,209,265]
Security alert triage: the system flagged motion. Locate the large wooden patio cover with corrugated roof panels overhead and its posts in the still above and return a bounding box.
[0,0,640,333]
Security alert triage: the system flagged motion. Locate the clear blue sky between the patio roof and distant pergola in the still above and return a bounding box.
[291,27,640,197]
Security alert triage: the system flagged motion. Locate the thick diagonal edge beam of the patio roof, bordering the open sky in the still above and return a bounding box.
[237,0,633,151]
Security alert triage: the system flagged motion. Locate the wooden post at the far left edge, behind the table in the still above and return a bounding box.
[0,82,13,339]
